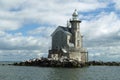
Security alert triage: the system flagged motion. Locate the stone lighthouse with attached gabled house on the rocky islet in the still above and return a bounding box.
[48,10,88,62]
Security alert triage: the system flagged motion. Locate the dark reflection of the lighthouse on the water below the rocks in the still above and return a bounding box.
[49,68,87,80]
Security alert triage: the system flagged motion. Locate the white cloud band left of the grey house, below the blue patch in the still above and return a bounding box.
[0,32,50,53]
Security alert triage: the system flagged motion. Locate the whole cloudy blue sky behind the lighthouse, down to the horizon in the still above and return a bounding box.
[0,0,120,61]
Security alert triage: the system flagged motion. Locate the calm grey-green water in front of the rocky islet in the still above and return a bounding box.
[0,62,120,80]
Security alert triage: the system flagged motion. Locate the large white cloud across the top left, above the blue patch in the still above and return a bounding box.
[0,0,107,28]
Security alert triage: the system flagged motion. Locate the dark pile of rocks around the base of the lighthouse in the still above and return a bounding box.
[13,58,86,68]
